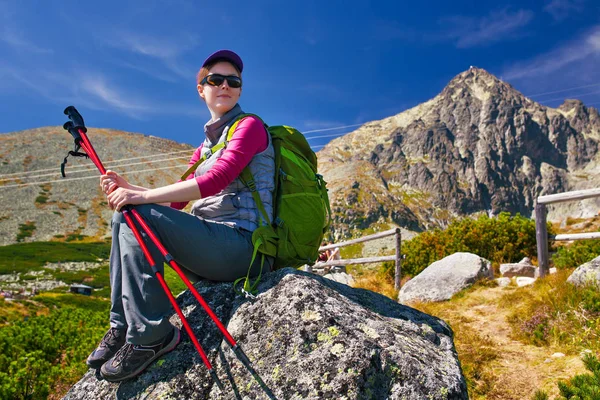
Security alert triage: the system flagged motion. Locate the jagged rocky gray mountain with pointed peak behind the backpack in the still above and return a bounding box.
[319,68,600,235]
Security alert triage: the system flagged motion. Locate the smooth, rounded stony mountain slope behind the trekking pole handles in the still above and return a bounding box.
[0,127,193,245]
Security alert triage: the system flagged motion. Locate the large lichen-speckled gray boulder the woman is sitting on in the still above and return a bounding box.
[65,269,468,400]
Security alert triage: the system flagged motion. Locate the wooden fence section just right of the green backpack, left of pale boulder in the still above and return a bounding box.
[309,228,402,290]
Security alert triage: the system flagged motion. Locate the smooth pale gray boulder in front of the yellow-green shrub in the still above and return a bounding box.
[398,253,494,304]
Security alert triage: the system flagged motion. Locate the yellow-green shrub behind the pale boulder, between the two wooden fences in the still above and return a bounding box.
[402,212,552,276]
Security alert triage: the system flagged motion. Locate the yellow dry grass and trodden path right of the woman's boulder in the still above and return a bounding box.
[412,286,586,400]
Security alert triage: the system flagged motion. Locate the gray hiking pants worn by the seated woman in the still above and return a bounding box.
[110,204,270,345]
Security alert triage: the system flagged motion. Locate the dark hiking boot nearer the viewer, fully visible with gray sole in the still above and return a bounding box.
[100,328,180,382]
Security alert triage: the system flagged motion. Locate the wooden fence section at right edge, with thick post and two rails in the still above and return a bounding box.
[535,188,600,276]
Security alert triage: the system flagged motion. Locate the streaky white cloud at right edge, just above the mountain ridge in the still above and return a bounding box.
[502,25,600,81]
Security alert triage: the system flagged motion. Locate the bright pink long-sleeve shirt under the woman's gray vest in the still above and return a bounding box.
[171,116,269,210]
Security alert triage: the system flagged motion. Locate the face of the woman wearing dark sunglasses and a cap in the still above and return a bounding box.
[198,61,242,120]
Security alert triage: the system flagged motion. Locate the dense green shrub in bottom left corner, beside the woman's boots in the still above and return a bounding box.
[0,300,109,399]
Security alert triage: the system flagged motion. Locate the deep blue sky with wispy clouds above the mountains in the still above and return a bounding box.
[0,0,600,150]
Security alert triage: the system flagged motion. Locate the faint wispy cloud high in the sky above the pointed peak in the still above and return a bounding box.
[440,9,533,48]
